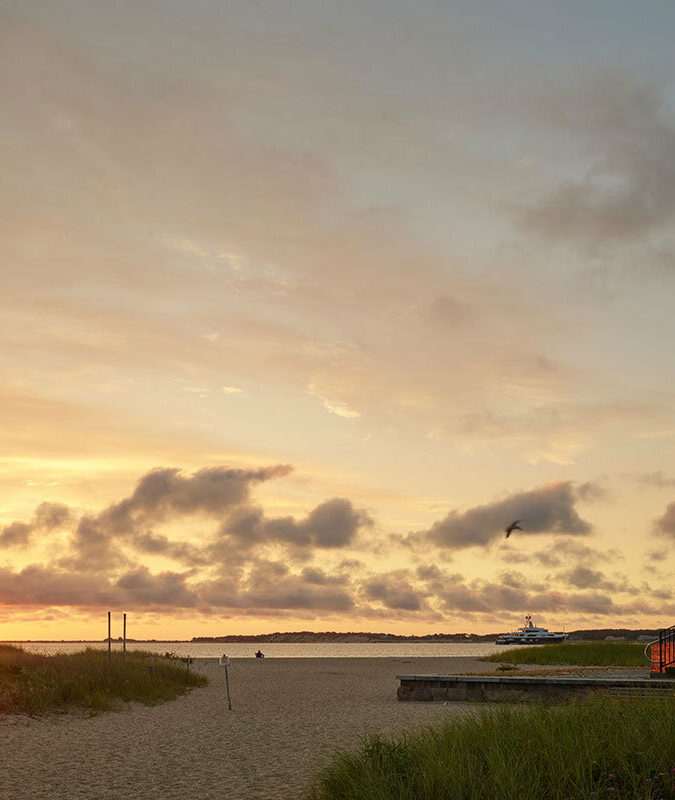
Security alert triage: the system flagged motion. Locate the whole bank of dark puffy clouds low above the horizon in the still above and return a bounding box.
[0,465,664,621]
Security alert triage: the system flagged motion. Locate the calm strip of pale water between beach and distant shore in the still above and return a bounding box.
[2,642,504,658]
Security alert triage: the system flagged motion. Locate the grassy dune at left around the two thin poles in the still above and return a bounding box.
[0,645,207,714]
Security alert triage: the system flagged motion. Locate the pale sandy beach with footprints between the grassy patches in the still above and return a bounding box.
[0,658,494,800]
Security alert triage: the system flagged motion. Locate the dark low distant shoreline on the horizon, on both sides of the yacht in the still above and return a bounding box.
[192,628,659,644]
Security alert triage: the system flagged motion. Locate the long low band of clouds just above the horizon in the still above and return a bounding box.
[0,557,656,627]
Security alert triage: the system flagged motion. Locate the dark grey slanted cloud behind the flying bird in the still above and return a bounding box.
[426,481,592,549]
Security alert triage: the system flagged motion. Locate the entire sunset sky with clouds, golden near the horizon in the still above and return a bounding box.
[0,0,675,640]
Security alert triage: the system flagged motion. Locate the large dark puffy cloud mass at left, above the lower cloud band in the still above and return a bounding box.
[0,465,373,574]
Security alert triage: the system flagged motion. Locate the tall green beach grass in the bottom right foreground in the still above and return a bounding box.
[307,696,675,800]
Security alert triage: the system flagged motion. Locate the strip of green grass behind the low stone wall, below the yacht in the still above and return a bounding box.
[483,642,649,667]
